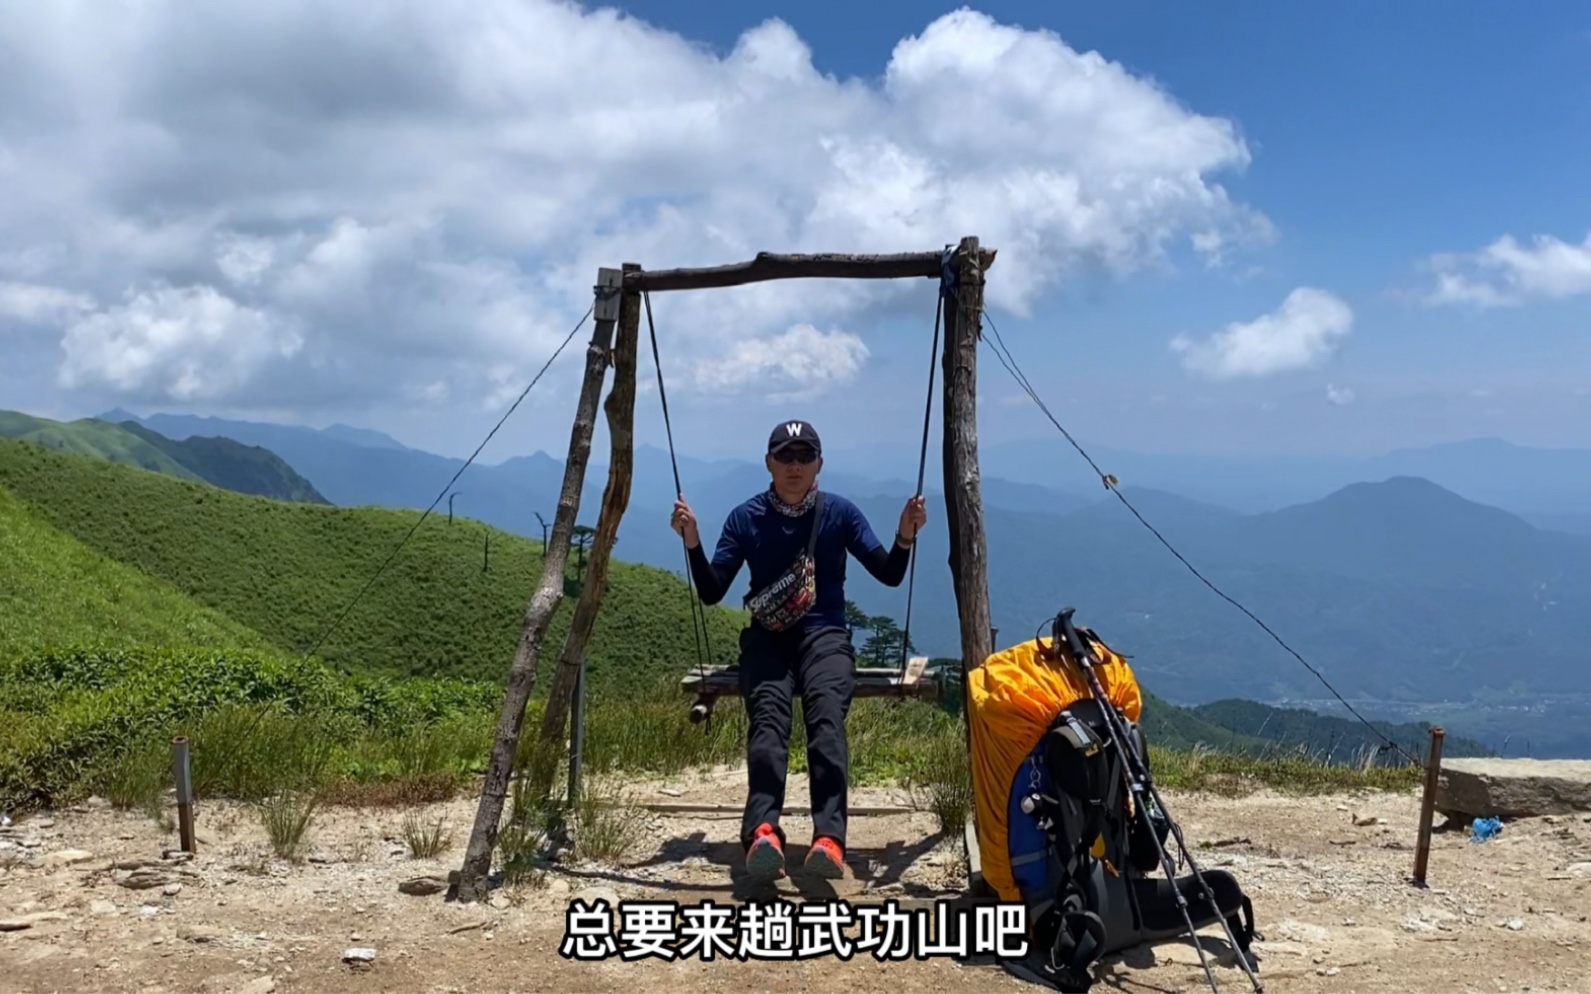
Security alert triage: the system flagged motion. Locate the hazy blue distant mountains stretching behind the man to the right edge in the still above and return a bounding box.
[93,405,1591,744]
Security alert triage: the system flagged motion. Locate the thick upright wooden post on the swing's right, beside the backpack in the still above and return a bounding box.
[943,237,994,894]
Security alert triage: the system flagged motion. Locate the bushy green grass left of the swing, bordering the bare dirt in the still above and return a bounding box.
[0,649,501,808]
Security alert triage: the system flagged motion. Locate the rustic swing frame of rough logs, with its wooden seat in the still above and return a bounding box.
[455,237,996,902]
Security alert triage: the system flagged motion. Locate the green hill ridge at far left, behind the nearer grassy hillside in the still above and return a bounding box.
[0,410,326,504]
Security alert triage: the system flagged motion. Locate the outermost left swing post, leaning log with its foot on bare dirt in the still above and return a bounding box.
[457,269,624,903]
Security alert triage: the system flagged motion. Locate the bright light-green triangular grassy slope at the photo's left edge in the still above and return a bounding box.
[0,487,266,660]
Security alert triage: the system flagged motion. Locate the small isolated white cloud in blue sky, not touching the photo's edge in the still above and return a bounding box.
[1171,286,1354,380]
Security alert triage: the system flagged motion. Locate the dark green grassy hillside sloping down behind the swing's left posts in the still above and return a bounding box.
[0,441,740,693]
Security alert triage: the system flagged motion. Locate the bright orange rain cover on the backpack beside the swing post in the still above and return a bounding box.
[967,628,1144,900]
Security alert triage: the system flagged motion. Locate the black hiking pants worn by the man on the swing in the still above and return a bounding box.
[740,622,856,848]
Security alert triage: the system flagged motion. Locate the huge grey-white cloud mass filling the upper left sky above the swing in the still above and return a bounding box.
[0,0,1273,409]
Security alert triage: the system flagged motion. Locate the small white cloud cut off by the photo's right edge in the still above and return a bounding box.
[1426,234,1591,307]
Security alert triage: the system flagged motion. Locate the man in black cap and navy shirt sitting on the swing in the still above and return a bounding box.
[671,421,928,879]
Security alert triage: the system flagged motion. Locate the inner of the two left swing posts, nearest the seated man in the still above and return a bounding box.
[535,262,641,803]
